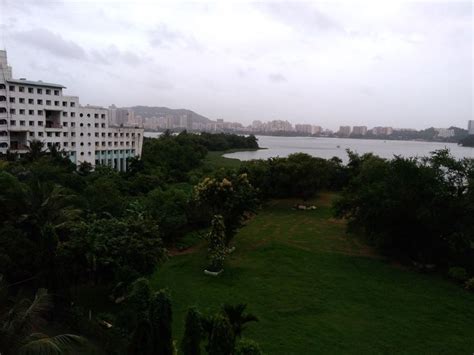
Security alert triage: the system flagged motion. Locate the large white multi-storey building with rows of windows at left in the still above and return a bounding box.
[0,51,143,171]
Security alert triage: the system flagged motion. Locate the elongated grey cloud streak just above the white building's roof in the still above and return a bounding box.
[11,28,86,59]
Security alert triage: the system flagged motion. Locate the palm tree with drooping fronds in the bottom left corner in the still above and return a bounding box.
[0,289,86,355]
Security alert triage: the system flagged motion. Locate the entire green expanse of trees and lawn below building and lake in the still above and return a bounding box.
[0,132,474,355]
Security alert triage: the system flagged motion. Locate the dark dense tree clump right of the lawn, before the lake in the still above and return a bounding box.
[336,151,474,272]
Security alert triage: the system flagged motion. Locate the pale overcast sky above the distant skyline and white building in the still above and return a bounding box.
[0,0,474,129]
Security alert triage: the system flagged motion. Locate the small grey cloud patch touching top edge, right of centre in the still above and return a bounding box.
[257,2,343,32]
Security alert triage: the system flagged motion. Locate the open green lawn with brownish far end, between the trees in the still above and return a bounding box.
[152,194,474,354]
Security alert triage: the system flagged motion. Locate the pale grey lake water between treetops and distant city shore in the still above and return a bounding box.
[224,136,474,162]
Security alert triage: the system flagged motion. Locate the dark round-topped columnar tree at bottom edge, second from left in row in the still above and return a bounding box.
[150,291,173,355]
